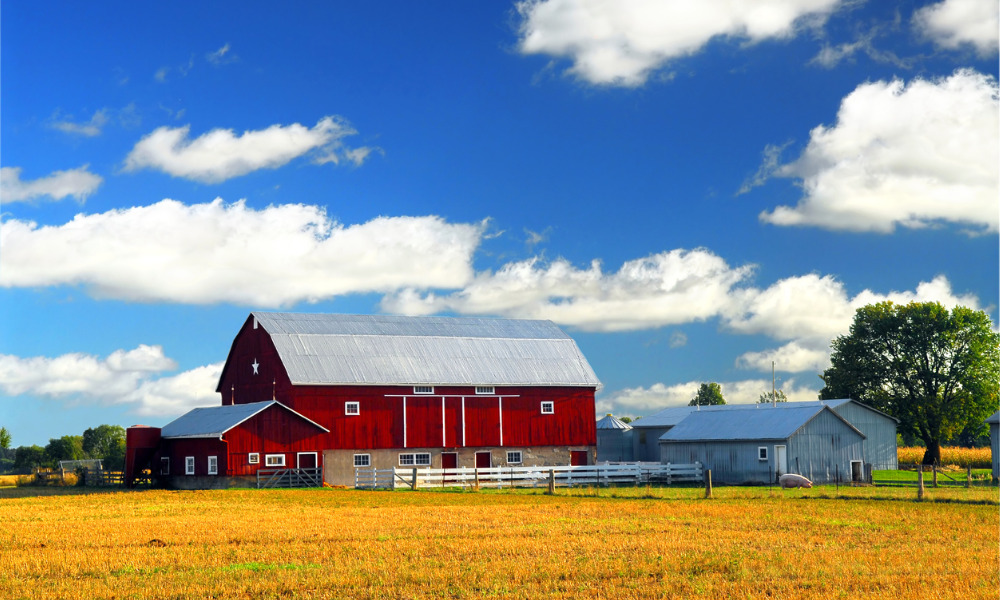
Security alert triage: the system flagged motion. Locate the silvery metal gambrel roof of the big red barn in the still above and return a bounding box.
[252,312,601,388]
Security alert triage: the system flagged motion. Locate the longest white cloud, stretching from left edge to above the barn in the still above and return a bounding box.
[0,200,485,306]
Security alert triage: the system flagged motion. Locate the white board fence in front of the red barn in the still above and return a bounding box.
[354,463,704,489]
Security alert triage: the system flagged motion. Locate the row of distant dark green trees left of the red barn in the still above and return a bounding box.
[0,425,125,473]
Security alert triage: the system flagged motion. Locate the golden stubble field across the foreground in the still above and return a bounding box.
[0,487,1000,599]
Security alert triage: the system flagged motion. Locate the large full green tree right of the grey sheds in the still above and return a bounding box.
[820,302,1000,464]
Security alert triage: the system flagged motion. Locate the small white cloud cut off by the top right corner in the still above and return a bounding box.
[913,0,1000,56]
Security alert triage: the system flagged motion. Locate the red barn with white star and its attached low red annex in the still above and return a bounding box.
[132,312,600,485]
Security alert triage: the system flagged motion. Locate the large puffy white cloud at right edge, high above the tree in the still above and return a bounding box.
[760,70,1000,233]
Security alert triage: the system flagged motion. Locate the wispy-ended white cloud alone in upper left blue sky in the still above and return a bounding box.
[124,117,377,183]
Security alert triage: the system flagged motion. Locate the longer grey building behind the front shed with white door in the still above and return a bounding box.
[632,398,899,469]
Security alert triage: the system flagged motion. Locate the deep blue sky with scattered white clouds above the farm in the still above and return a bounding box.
[0,0,1000,446]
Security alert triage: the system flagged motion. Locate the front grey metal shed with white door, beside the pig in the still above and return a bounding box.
[659,402,867,484]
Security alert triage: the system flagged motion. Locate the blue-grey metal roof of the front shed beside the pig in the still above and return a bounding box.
[660,402,865,442]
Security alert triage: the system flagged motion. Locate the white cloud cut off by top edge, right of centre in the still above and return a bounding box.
[517,0,839,87]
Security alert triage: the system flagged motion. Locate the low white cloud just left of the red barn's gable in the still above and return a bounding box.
[0,344,223,416]
